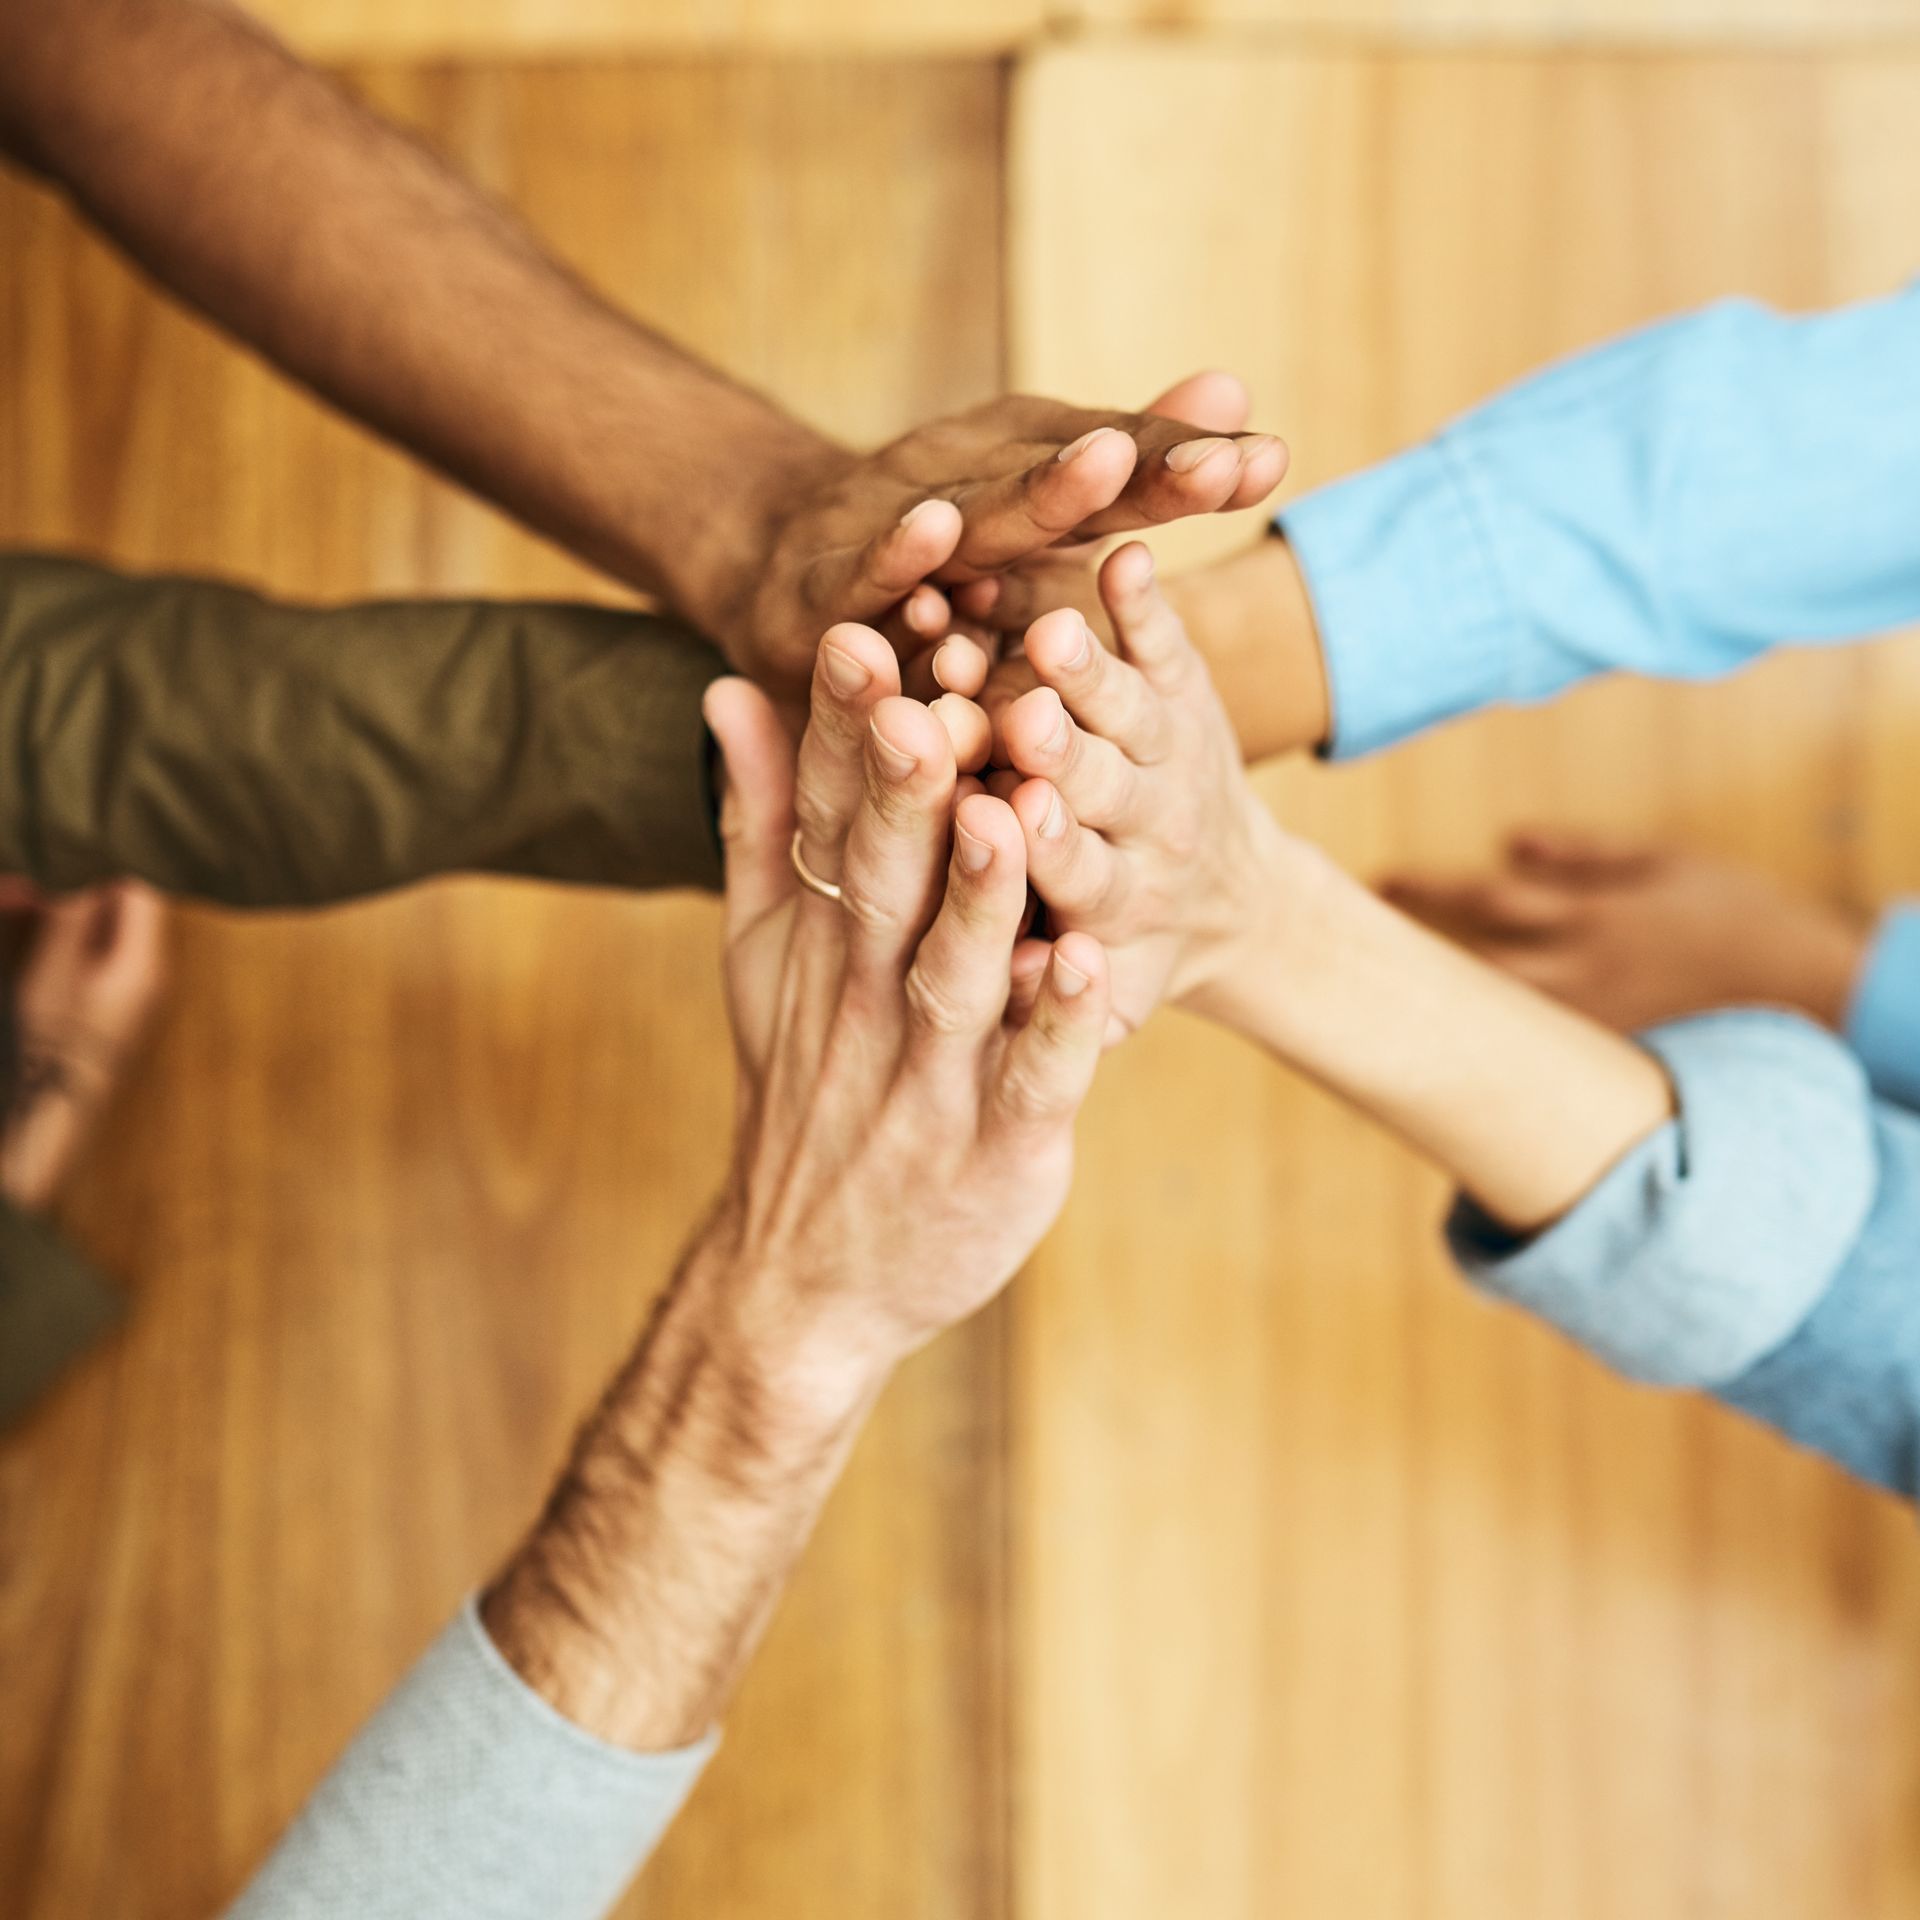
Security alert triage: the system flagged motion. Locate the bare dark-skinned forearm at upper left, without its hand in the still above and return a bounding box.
[0,0,831,630]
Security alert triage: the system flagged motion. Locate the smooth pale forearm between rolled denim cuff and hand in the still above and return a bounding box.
[1190,837,1672,1233]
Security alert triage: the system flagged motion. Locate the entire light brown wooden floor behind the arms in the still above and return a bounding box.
[0,0,1920,1920]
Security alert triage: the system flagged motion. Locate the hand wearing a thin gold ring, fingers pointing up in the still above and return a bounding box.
[708,626,1108,1384]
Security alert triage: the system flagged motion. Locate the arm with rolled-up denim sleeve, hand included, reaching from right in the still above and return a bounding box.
[967,547,1920,1494]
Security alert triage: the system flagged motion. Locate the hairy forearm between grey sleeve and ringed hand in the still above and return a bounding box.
[482,1235,885,1751]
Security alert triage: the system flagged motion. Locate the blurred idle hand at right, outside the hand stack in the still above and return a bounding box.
[1380,831,1868,1033]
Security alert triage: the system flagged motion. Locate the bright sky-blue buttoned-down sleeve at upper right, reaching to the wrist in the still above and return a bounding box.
[1281,284,1920,755]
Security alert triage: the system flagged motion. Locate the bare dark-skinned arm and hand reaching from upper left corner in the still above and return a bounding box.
[0,0,1284,689]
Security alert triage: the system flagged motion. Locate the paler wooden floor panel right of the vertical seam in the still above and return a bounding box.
[1012,38,1920,1920]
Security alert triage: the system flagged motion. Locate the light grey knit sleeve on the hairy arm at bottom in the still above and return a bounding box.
[228,1601,718,1920]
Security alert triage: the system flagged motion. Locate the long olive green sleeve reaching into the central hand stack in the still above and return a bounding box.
[0,555,724,906]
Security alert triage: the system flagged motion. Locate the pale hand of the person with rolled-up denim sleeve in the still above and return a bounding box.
[935,541,1281,1037]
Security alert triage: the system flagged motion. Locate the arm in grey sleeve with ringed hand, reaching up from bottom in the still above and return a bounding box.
[222,626,1108,1920]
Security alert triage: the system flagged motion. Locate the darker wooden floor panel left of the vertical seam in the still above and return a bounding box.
[0,61,1008,1920]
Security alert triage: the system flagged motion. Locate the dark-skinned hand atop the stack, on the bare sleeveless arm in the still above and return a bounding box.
[710,374,1286,689]
